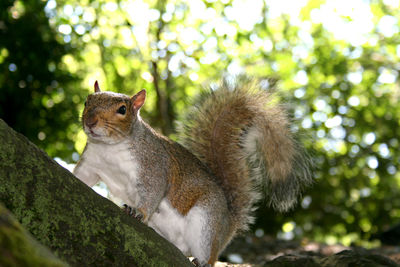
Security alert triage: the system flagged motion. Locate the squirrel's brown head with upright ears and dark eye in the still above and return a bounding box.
[82,81,146,144]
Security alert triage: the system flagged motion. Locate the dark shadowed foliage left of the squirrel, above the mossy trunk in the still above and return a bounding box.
[0,0,86,160]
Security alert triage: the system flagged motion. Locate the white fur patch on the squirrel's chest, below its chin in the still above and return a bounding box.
[84,142,139,207]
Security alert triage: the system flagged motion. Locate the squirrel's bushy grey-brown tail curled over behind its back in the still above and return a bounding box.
[182,79,312,230]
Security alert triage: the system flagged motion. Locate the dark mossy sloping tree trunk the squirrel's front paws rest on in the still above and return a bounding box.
[0,119,192,266]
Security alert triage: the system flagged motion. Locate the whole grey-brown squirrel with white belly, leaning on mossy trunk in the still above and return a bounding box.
[74,79,312,266]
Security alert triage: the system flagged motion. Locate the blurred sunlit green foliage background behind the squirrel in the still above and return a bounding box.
[0,0,400,246]
